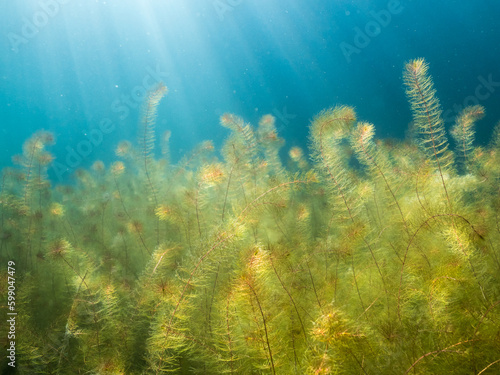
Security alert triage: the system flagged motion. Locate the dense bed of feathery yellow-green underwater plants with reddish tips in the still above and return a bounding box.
[0,59,500,375]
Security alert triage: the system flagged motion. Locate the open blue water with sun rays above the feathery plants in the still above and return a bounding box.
[0,0,500,180]
